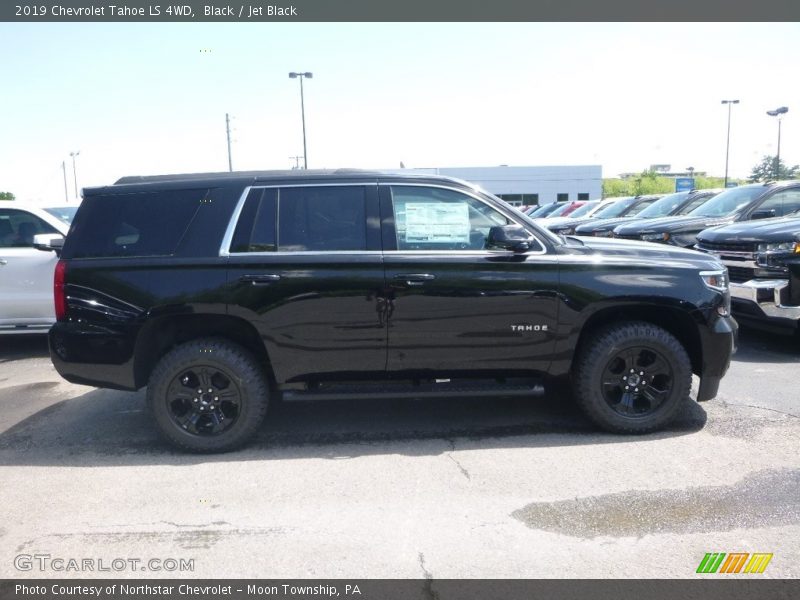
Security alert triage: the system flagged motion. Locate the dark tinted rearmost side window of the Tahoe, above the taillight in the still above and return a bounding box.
[64,189,208,258]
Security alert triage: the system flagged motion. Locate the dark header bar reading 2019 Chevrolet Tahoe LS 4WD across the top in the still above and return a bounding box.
[0,0,800,23]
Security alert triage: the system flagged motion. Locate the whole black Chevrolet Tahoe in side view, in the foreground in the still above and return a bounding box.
[49,170,736,452]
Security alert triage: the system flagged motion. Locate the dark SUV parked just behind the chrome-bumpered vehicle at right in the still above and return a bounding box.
[614,181,800,248]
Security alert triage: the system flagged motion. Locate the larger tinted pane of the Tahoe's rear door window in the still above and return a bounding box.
[278,186,367,252]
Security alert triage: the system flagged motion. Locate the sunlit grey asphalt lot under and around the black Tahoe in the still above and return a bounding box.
[0,330,800,578]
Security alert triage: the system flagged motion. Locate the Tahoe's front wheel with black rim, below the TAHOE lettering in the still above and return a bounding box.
[572,321,692,433]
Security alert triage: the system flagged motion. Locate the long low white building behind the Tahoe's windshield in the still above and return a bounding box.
[406,165,603,205]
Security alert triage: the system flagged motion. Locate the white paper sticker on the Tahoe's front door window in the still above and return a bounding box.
[405,202,470,244]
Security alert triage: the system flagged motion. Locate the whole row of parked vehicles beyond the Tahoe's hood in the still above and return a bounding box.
[524,181,800,333]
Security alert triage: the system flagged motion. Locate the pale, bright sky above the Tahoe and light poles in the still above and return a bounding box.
[0,23,800,203]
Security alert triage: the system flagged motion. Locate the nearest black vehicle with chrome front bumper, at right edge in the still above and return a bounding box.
[696,214,800,333]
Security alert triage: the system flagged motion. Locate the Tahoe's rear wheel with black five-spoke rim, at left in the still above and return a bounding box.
[147,339,269,452]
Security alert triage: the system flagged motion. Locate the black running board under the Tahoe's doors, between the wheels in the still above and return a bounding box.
[282,383,544,402]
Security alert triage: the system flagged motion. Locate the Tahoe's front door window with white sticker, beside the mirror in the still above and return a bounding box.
[392,186,509,250]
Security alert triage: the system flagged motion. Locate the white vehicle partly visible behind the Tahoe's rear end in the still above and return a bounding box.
[0,201,78,335]
